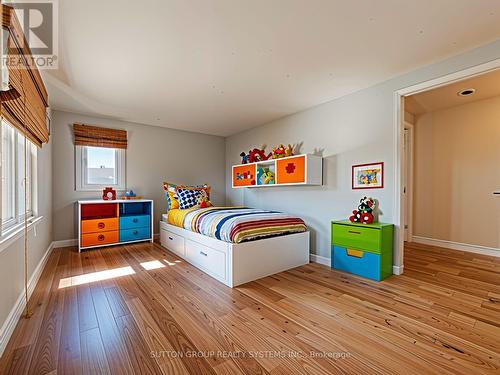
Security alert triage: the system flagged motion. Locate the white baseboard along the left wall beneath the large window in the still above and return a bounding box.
[0,242,54,357]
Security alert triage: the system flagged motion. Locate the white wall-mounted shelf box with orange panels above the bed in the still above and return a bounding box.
[232,154,323,188]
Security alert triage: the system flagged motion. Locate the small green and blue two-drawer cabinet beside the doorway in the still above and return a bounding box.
[332,220,393,281]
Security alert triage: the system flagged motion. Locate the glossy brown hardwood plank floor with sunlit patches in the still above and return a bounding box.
[0,243,500,375]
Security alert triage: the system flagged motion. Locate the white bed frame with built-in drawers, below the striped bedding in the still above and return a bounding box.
[160,215,309,288]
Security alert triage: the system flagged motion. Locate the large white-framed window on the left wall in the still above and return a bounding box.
[0,121,37,236]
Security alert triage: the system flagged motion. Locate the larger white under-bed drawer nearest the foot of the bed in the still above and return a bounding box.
[185,240,226,280]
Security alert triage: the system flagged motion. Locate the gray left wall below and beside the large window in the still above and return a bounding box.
[0,137,53,327]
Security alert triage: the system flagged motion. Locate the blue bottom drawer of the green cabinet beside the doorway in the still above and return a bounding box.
[332,245,380,281]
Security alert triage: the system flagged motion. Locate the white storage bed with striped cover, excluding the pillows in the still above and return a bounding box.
[160,207,309,287]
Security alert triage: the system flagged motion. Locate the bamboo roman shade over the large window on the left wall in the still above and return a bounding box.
[0,5,49,147]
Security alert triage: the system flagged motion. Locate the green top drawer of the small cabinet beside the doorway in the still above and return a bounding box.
[332,223,381,254]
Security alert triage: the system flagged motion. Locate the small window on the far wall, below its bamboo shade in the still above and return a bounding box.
[75,146,125,191]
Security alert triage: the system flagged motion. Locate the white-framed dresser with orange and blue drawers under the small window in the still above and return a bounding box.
[77,199,153,251]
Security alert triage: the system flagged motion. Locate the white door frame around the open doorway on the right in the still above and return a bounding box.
[393,59,500,275]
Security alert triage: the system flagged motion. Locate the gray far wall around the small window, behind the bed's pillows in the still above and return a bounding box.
[52,111,225,241]
